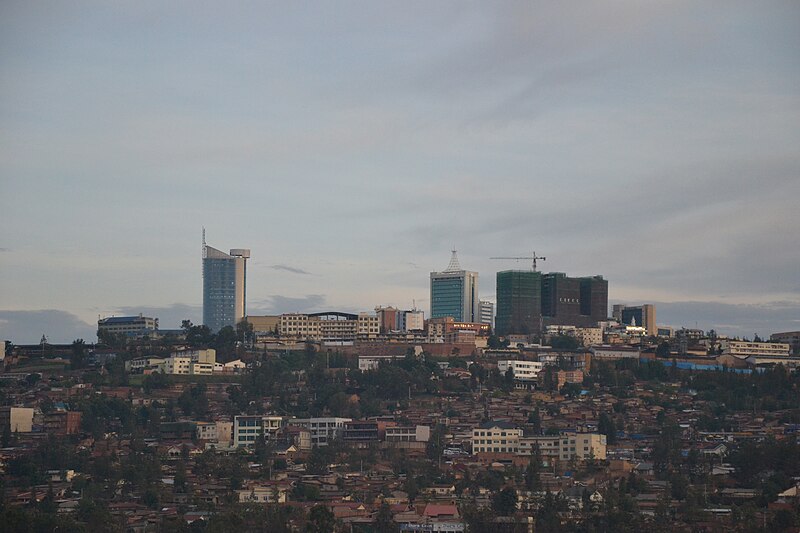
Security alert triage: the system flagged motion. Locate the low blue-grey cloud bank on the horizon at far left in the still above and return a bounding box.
[0,309,97,344]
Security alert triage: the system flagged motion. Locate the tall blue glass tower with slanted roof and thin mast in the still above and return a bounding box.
[203,238,250,333]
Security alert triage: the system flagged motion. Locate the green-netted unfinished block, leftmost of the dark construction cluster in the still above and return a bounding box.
[495,270,542,335]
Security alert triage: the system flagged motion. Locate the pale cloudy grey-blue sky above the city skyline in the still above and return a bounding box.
[0,0,800,344]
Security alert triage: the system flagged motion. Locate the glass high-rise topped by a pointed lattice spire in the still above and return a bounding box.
[430,250,480,322]
